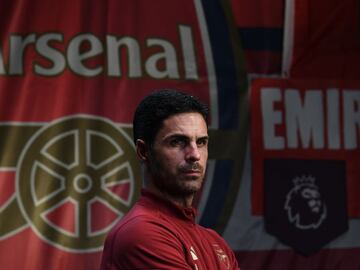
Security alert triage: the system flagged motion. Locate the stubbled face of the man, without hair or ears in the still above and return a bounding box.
[149,112,208,198]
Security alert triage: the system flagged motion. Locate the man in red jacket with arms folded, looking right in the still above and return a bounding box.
[101,90,239,270]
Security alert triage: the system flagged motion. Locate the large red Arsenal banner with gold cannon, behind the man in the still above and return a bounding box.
[0,0,246,270]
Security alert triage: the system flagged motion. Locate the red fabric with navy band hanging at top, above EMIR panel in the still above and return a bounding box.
[231,0,285,75]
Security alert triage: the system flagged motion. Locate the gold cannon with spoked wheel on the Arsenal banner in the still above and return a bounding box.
[0,115,141,252]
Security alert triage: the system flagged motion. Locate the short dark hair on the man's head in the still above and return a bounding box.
[133,89,209,145]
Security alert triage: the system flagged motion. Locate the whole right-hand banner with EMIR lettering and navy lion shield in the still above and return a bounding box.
[242,76,360,269]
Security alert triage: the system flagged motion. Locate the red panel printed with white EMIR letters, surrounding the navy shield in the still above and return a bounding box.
[251,79,360,217]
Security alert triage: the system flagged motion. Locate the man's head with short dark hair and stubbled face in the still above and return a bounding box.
[134,90,208,205]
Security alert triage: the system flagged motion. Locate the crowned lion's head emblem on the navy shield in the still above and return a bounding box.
[285,176,327,230]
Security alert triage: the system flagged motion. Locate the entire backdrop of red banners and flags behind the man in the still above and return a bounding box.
[0,0,360,270]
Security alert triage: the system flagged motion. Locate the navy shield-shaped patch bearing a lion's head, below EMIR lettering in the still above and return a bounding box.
[264,159,348,256]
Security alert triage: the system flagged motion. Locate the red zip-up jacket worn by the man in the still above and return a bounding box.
[101,190,239,270]
